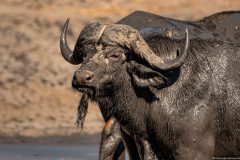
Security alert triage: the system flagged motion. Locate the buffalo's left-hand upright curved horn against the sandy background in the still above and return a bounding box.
[60,18,82,65]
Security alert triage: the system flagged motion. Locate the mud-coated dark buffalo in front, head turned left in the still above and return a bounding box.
[62,10,239,159]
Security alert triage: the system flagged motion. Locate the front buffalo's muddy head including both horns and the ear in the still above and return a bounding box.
[60,19,189,97]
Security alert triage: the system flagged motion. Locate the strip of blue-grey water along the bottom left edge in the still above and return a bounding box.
[0,144,99,160]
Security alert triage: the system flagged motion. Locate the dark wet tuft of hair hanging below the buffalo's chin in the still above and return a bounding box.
[76,94,88,130]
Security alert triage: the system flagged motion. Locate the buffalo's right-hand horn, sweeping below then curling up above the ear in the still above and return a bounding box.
[130,29,189,71]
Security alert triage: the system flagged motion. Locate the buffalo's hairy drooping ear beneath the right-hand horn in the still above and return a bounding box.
[128,61,168,89]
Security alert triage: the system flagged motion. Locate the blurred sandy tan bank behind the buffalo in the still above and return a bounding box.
[0,0,240,159]
